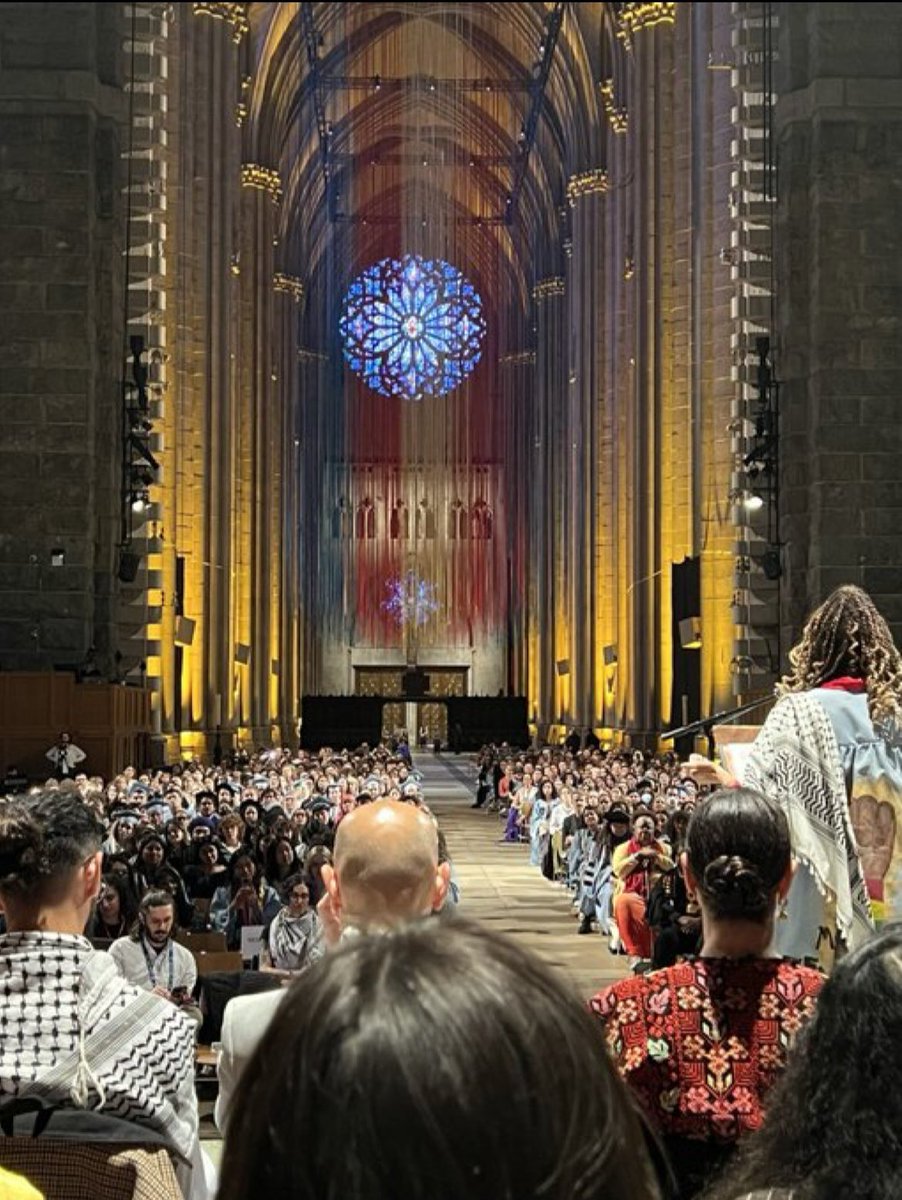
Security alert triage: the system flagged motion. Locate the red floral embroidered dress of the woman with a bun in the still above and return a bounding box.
[590,958,824,1141]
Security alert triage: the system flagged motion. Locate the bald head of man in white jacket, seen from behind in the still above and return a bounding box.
[323,800,449,929]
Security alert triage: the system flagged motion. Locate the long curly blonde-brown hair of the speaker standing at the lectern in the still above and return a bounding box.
[777,583,902,727]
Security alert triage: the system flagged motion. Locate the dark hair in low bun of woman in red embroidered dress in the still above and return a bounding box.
[686,787,790,920]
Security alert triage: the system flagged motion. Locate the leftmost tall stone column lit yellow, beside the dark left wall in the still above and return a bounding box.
[164,5,240,751]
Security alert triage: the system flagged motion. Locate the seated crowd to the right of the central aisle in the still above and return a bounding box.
[474,745,702,970]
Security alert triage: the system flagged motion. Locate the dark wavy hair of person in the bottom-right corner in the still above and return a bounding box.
[705,923,902,1200]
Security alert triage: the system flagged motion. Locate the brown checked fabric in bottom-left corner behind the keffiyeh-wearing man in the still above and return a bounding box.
[0,1138,182,1200]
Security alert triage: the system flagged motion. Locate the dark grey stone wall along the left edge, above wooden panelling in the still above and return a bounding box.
[0,4,125,671]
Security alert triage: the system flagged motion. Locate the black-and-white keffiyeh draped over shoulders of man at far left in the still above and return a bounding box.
[0,931,198,1158]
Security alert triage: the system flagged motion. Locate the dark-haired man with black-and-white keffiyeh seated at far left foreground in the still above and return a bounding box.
[0,787,198,1190]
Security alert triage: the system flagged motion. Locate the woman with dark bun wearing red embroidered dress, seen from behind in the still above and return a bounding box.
[591,788,823,1196]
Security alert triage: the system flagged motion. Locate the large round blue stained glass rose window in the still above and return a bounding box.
[339,254,486,400]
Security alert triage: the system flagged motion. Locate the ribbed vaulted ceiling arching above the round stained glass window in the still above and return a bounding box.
[248,2,608,324]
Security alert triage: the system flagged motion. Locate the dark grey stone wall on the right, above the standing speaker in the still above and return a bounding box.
[775,4,902,646]
